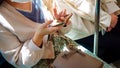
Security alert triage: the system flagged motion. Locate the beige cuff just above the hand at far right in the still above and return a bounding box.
[106,2,120,14]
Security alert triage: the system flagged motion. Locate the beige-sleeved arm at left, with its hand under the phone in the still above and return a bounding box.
[0,2,62,68]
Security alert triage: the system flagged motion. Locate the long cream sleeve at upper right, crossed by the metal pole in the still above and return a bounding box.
[58,0,111,30]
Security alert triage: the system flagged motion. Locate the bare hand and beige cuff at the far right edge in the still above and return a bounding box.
[105,0,120,32]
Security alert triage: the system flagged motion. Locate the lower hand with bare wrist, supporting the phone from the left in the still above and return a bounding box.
[32,21,61,46]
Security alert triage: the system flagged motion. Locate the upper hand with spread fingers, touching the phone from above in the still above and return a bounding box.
[54,8,72,25]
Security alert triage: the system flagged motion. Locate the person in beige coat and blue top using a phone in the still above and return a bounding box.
[0,0,70,68]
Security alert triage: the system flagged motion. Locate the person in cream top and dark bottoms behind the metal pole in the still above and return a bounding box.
[56,0,120,63]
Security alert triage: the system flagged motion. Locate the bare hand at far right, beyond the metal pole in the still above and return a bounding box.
[107,13,118,32]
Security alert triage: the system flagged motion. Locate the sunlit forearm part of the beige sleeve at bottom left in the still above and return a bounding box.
[2,40,44,68]
